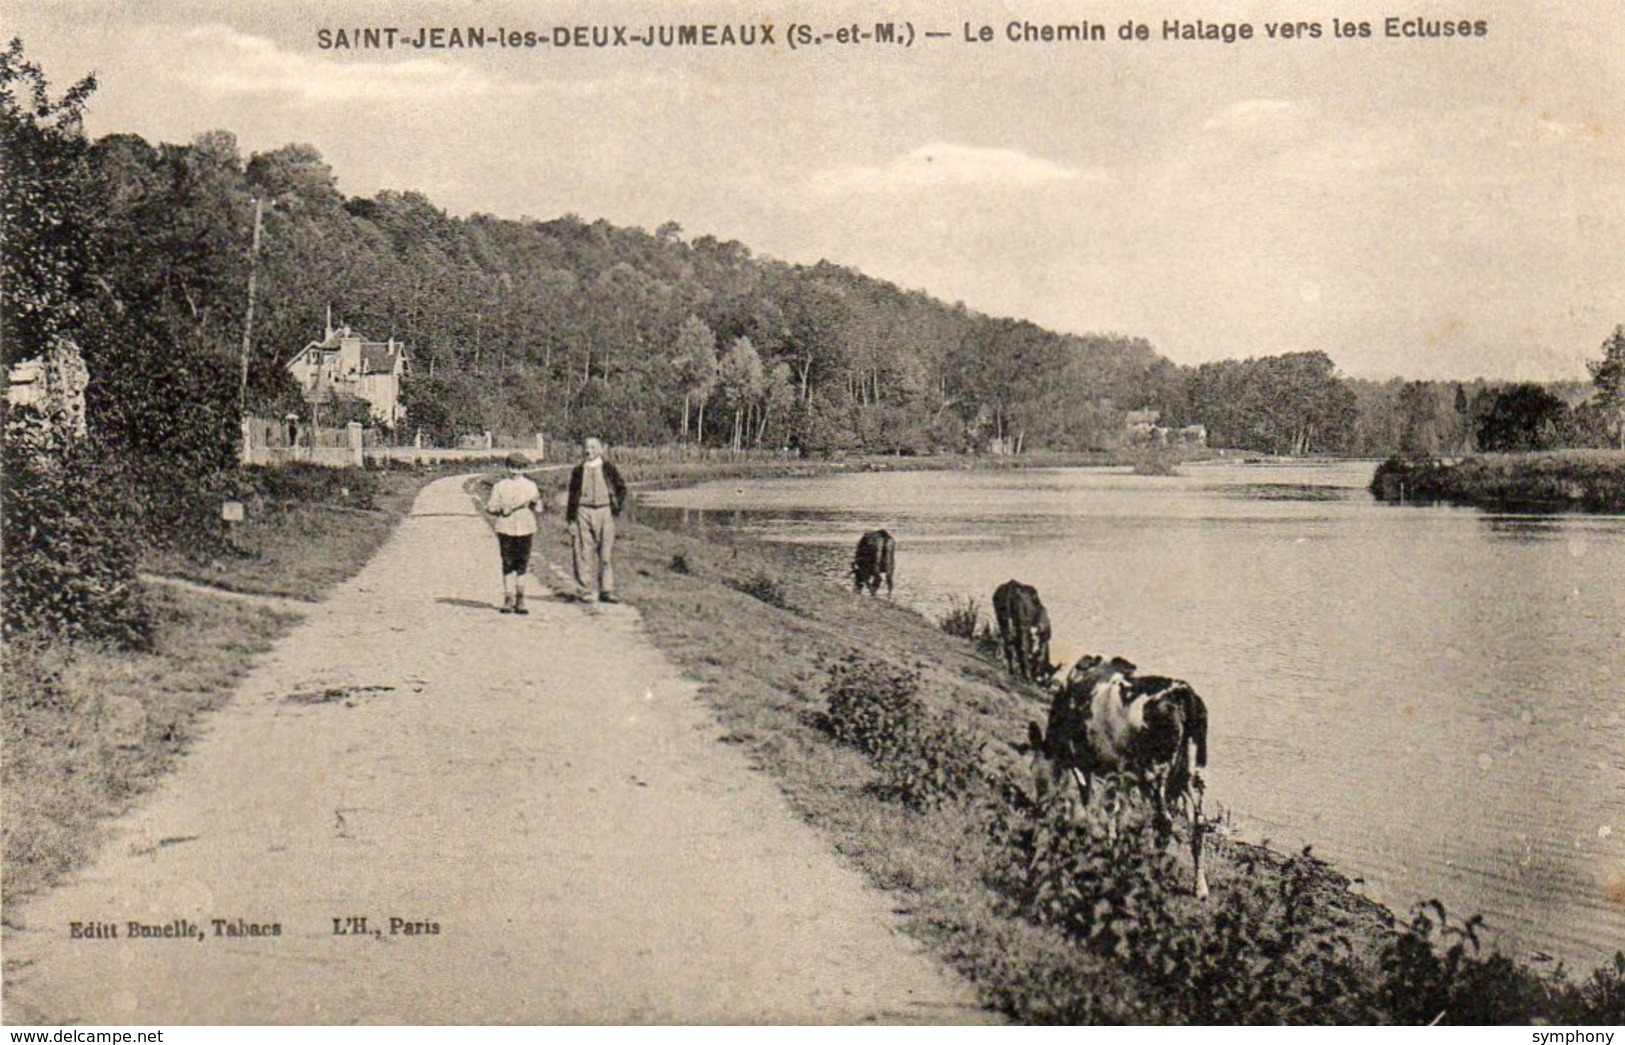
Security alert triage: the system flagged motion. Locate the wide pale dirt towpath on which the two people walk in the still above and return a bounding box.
[5,479,986,1024]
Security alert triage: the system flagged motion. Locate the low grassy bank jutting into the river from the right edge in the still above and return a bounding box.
[1372,450,1625,512]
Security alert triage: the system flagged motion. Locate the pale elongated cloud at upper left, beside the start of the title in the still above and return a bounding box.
[174,24,496,106]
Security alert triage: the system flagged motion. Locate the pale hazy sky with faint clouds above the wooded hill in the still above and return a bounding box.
[0,0,1625,380]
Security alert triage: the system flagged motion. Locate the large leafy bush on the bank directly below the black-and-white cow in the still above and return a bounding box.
[986,775,1375,1024]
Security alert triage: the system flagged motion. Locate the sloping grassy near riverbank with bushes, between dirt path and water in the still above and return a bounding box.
[604,503,1625,1024]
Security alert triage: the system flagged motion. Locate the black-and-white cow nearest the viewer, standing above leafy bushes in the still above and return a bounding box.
[1027,657,1207,899]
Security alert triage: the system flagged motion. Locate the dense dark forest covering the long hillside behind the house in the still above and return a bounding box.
[0,42,1615,477]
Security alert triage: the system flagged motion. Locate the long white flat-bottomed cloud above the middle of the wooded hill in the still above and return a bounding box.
[809,141,1107,195]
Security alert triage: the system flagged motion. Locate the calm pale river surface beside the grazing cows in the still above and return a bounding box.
[640,463,1625,969]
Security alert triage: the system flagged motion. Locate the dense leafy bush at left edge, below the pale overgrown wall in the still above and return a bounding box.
[0,427,153,648]
